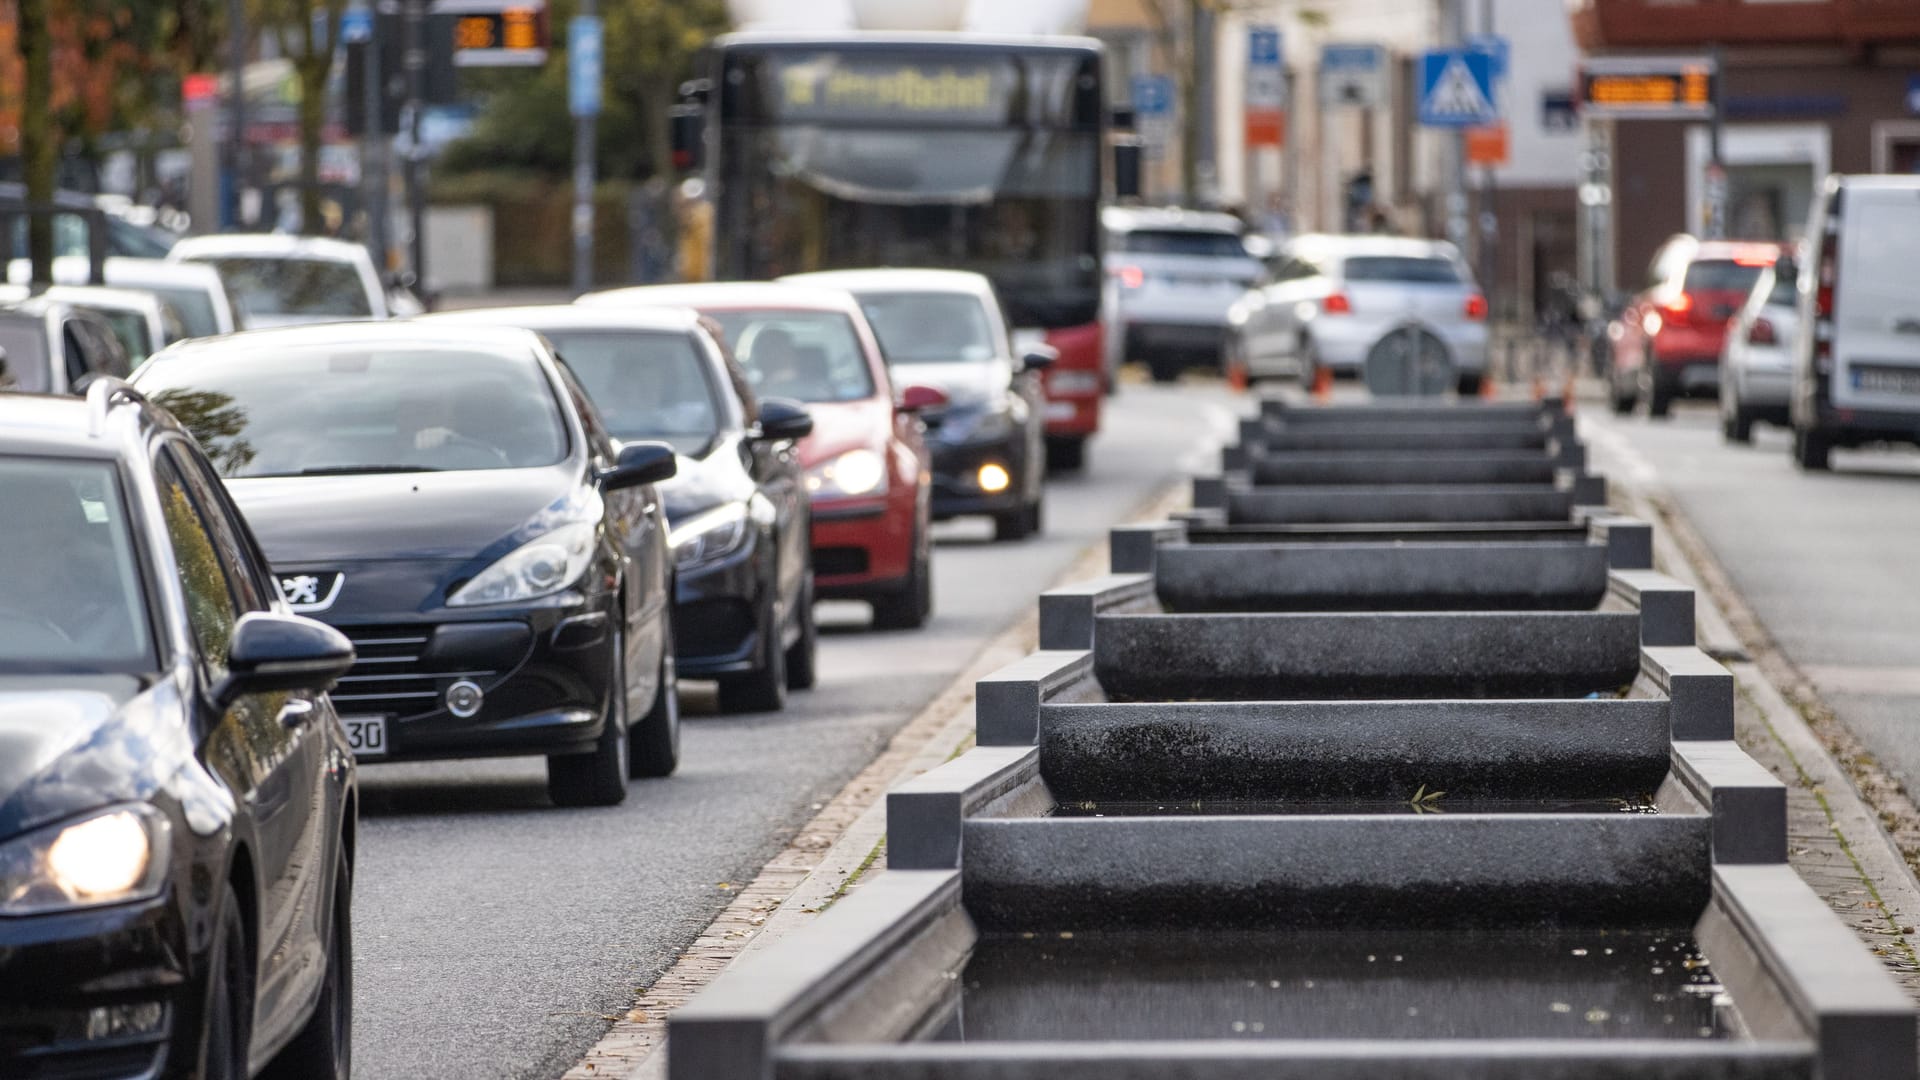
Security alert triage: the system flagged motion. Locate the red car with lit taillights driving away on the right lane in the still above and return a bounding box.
[1607,234,1782,417]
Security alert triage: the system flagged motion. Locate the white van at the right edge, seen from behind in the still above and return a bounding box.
[1791,175,1920,469]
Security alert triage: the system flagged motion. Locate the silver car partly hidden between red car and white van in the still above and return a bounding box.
[1720,256,1799,442]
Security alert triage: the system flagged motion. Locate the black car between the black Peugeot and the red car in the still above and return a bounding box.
[430,306,818,713]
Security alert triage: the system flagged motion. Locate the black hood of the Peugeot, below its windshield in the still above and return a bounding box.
[227,463,583,567]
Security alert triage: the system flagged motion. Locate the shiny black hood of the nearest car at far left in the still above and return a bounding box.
[0,675,192,840]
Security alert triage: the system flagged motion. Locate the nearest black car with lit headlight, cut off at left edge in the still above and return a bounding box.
[0,379,357,1080]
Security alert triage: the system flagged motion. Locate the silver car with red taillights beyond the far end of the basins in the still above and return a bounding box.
[1229,234,1486,394]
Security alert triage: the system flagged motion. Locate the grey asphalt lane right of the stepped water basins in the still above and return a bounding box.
[1586,404,1920,792]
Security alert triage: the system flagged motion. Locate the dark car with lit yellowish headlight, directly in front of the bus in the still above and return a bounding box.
[785,269,1056,540]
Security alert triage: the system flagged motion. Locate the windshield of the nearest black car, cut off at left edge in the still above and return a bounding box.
[0,455,157,675]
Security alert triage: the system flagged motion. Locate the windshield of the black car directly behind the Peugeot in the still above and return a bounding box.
[545,331,720,450]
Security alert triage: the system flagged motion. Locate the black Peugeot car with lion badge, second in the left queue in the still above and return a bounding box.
[136,323,680,805]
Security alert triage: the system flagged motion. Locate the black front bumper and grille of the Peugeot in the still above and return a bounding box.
[334,592,616,761]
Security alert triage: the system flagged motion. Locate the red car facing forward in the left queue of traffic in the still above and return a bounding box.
[578,282,947,630]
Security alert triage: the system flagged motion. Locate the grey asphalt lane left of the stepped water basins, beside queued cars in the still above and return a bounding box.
[353,382,1233,1080]
